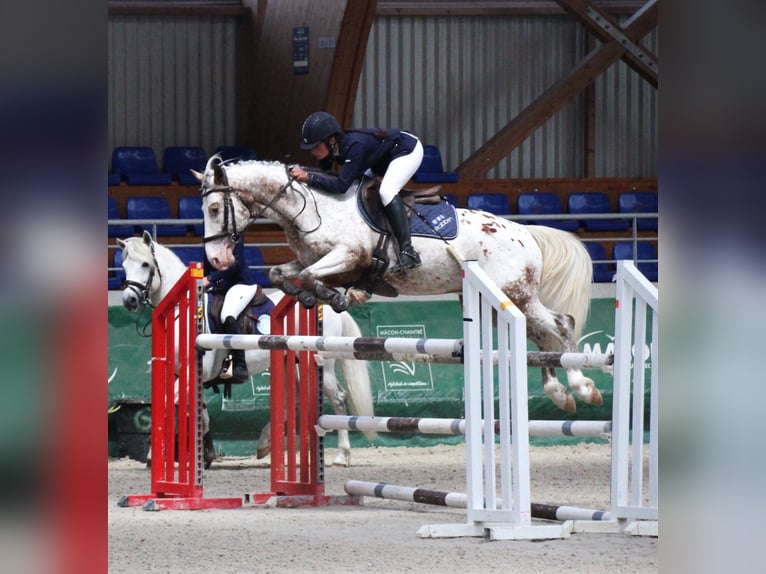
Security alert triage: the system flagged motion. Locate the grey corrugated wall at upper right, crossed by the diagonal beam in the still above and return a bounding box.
[354,15,657,178]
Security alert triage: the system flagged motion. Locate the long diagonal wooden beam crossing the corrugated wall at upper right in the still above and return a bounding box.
[456,0,658,180]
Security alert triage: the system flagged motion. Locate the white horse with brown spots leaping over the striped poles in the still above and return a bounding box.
[192,155,603,413]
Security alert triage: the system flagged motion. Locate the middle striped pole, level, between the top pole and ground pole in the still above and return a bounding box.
[317,415,612,437]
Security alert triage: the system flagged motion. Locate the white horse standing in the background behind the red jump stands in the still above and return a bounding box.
[117,231,377,467]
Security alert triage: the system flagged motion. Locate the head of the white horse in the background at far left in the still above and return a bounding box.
[117,231,162,311]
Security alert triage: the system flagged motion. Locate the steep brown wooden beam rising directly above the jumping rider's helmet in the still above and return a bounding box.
[323,0,378,126]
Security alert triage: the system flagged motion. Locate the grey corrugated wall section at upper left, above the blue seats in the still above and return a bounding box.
[108,15,238,166]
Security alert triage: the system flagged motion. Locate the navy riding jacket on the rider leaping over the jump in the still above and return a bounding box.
[308,129,418,193]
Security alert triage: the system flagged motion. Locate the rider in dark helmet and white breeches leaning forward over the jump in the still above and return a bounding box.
[290,112,423,271]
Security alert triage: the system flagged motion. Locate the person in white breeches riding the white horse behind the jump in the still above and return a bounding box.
[202,236,258,383]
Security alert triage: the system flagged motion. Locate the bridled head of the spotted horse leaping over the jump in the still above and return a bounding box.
[194,155,252,269]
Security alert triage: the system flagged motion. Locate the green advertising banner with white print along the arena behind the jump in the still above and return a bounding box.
[109,298,651,454]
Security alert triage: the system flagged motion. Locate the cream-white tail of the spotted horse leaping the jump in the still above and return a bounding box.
[527,225,593,340]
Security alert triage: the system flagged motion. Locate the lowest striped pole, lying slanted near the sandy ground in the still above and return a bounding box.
[343,480,611,521]
